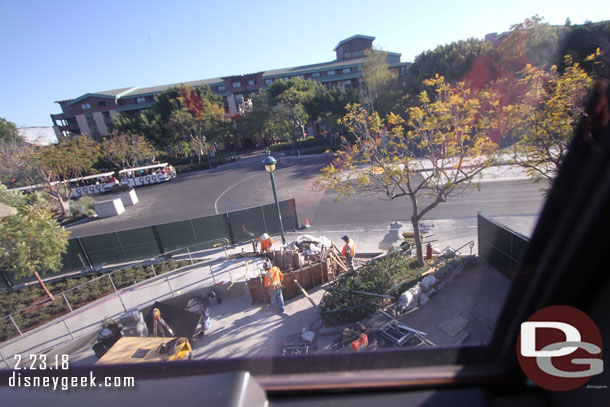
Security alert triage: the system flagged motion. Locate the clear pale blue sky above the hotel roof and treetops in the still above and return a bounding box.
[0,0,610,127]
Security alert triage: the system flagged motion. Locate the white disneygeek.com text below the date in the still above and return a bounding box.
[8,371,135,391]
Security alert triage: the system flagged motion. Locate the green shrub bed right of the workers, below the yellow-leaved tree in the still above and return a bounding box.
[320,252,421,323]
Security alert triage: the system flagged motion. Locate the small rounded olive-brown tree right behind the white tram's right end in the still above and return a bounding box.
[101,133,157,169]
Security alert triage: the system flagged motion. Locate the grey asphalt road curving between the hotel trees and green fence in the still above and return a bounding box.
[67,156,543,236]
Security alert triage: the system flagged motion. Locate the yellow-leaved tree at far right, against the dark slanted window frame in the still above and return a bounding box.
[506,56,592,181]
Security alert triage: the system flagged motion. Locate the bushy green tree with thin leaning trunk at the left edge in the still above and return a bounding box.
[0,185,69,299]
